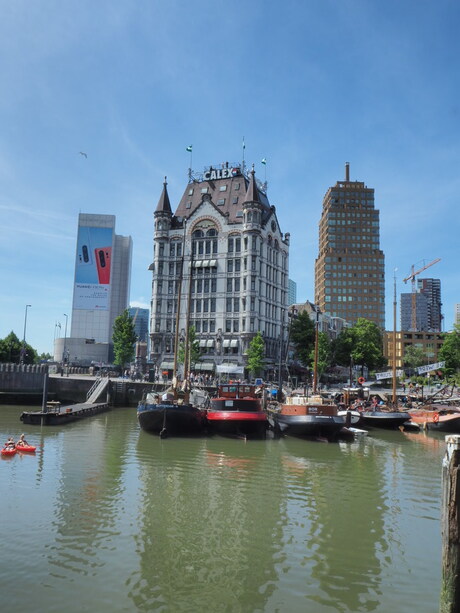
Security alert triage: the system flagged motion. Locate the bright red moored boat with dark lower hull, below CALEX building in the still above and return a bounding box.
[206,383,268,438]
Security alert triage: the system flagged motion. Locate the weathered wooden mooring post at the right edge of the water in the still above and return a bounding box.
[439,434,460,613]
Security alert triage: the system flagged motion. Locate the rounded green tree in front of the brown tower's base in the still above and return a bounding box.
[334,317,386,370]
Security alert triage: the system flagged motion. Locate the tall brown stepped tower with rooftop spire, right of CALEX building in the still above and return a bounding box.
[315,163,385,329]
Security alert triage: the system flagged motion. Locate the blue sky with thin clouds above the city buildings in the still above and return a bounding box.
[0,0,460,353]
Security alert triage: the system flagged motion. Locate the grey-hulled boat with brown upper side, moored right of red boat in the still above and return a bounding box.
[268,395,345,438]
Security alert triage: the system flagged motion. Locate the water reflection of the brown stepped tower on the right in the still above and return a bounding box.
[274,439,386,611]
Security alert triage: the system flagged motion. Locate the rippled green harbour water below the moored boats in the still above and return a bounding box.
[0,407,445,613]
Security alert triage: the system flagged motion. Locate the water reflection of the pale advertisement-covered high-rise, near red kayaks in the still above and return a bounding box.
[47,414,133,580]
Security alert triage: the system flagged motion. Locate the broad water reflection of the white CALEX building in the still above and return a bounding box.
[128,433,281,611]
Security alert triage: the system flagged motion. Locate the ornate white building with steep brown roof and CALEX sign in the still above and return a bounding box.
[150,163,289,375]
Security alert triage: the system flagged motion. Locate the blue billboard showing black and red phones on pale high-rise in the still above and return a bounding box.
[73,226,113,311]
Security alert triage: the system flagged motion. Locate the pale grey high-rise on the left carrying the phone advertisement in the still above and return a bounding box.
[54,213,132,364]
